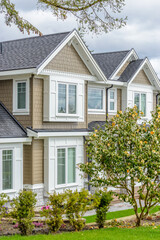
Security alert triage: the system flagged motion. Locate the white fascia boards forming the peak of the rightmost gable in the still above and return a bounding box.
[128,58,160,89]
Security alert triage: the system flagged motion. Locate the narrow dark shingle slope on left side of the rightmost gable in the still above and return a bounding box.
[118,59,144,82]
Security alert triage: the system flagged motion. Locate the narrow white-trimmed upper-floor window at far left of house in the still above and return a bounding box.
[13,79,29,115]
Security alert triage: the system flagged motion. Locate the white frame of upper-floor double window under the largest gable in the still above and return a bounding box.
[56,81,79,118]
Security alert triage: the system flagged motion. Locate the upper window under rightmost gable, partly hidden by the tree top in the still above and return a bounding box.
[134,93,146,116]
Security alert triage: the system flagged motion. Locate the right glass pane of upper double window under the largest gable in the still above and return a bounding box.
[68,85,76,114]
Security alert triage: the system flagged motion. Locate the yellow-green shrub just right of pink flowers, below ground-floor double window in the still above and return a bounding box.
[41,192,66,232]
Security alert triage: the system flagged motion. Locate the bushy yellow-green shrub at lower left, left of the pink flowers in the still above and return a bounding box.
[11,190,36,235]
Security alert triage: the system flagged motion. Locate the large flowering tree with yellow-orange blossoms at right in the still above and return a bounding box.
[80,106,160,226]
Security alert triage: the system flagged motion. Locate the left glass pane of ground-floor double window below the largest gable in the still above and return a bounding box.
[57,148,66,184]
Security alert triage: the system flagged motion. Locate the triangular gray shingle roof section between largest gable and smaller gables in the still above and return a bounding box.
[92,50,130,78]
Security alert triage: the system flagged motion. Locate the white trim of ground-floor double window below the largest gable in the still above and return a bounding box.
[55,145,78,189]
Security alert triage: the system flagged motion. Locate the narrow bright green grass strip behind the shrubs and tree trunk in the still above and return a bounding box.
[84,206,160,223]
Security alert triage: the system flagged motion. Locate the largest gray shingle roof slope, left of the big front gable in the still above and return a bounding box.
[0,32,69,71]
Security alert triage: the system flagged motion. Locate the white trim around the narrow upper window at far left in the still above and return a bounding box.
[13,78,30,115]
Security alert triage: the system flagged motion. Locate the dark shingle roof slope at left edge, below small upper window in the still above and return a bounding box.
[0,102,27,138]
